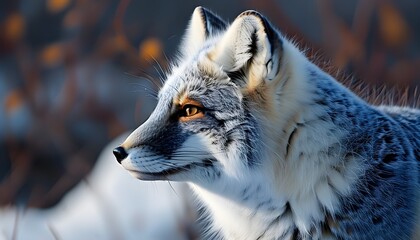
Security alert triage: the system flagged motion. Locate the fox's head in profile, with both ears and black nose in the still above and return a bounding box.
[114,7,300,183]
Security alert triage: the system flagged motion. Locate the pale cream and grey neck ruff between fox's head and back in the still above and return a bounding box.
[192,44,368,239]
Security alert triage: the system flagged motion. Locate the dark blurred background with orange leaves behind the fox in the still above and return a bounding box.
[0,0,420,213]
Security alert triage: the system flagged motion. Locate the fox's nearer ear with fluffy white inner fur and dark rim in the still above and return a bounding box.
[209,11,282,86]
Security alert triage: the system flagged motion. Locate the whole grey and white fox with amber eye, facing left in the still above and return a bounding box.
[114,7,420,240]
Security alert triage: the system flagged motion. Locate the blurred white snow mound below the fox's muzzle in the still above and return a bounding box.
[0,136,189,240]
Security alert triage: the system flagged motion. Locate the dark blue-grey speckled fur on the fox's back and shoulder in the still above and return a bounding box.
[309,69,420,240]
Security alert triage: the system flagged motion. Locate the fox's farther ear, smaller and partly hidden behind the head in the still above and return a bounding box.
[181,7,227,55]
